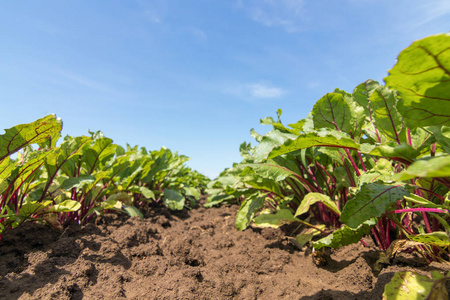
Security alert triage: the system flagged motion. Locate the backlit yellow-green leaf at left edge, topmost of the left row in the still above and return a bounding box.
[0,115,62,161]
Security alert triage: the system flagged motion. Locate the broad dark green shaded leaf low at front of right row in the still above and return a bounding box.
[340,183,409,228]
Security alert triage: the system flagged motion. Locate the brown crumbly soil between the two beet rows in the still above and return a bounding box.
[0,199,449,300]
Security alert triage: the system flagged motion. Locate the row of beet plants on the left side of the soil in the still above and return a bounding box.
[0,115,208,234]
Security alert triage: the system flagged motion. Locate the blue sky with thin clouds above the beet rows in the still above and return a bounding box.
[0,0,450,178]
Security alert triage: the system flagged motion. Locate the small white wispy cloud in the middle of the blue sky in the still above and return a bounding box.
[223,82,286,100]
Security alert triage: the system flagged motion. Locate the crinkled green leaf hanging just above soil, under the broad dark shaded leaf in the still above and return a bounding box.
[312,219,377,250]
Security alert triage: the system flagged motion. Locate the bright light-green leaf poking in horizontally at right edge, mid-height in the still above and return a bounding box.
[392,155,450,181]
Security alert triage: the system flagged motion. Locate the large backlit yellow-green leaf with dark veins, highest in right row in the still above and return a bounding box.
[384,33,450,127]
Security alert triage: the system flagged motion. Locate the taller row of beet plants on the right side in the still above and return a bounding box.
[207,34,450,261]
